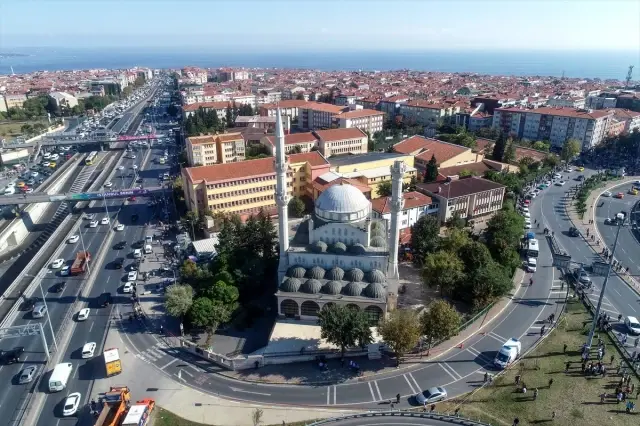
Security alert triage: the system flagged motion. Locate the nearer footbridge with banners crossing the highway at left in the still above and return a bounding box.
[0,185,172,206]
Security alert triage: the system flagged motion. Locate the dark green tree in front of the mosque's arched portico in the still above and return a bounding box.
[318,305,373,358]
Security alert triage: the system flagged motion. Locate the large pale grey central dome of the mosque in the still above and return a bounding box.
[315,183,371,223]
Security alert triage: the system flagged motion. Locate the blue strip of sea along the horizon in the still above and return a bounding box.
[0,47,640,81]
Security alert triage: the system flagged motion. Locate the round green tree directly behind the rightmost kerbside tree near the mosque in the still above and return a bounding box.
[422,250,464,296]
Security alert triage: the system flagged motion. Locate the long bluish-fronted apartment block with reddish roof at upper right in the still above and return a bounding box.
[492,107,613,151]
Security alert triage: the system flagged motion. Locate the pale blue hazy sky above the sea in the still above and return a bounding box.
[0,0,640,52]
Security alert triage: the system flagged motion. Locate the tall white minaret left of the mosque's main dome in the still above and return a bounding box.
[275,108,289,279]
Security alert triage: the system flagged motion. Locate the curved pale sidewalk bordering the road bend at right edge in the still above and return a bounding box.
[565,176,640,295]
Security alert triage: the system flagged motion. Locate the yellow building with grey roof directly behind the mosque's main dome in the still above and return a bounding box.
[328,152,417,199]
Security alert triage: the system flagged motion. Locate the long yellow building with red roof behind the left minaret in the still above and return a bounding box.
[182,152,329,217]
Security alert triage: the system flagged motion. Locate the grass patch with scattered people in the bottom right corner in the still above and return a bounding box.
[436,301,640,426]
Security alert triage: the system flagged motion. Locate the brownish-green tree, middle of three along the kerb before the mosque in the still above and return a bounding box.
[378,309,422,364]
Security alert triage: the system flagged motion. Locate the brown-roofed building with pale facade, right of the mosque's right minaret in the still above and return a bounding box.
[416,176,506,223]
